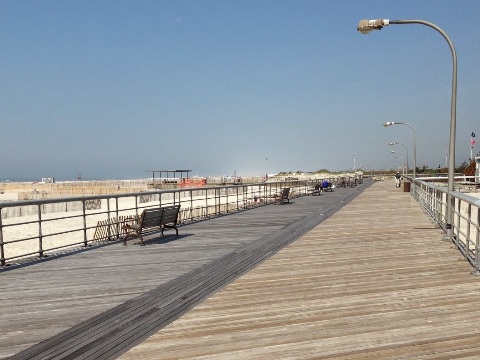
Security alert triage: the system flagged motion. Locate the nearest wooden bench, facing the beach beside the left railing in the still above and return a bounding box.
[122,205,180,245]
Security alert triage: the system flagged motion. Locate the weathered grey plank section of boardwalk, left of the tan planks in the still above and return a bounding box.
[0,181,366,359]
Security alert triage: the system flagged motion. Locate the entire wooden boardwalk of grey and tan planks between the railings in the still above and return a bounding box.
[4,181,480,359]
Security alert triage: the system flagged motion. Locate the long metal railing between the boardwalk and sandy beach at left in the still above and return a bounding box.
[0,179,342,266]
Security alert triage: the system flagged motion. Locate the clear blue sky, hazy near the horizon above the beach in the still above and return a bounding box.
[0,0,480,180]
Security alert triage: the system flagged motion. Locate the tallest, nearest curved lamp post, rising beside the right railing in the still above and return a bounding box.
[357,19,457,239]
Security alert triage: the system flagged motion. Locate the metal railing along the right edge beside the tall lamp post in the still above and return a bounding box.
[409,176,480,275]
